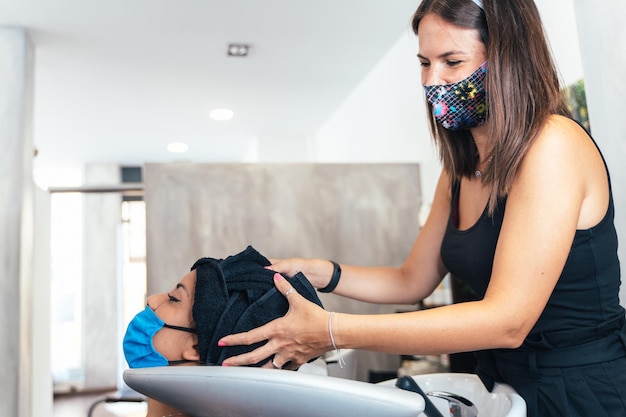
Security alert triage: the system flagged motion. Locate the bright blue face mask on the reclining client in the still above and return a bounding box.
[122,306,196,368]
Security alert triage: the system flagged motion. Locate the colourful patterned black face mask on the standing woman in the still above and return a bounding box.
[424,61,487,130]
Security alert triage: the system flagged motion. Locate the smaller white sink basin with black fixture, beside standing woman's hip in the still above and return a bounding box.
[379,373,526,417]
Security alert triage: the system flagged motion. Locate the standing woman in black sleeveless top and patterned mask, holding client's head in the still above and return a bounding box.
[219,0,626,417]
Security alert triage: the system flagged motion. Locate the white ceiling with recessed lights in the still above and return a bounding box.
[0,0,418,171]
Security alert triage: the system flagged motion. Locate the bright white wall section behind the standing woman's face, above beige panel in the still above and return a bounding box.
[313,25,440,205]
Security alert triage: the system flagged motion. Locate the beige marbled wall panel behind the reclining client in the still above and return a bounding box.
[144,163,421,379]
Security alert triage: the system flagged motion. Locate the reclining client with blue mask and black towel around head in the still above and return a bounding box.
[123,246,322,417]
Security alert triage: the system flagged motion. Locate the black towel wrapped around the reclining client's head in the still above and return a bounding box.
[191,246,322,366]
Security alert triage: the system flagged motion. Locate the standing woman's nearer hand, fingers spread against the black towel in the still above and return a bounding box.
[218,273,331,369]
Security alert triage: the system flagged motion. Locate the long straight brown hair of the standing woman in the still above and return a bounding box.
[412,0,571,214]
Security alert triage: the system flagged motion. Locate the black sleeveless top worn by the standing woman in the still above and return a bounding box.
[441,167,624,349]
